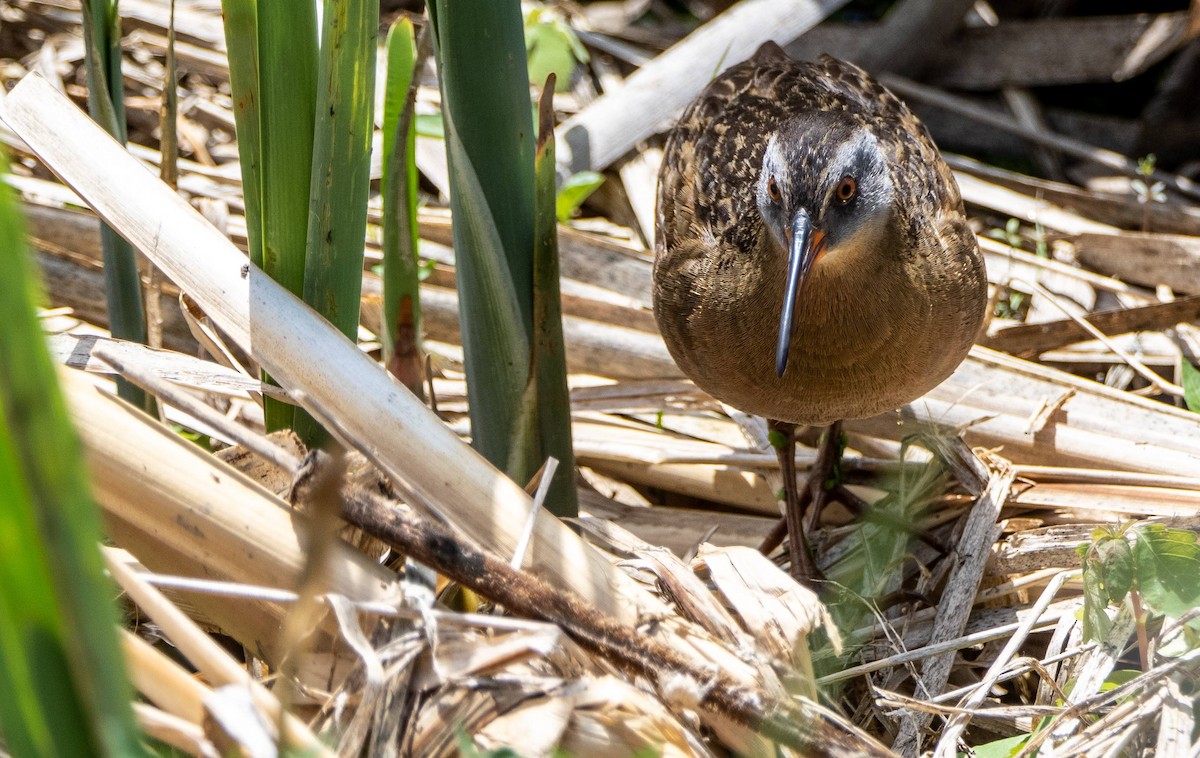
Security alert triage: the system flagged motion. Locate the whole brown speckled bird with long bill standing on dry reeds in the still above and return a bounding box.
[654,42,988,580]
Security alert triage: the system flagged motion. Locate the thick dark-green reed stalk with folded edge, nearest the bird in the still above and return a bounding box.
[428,0,534,482]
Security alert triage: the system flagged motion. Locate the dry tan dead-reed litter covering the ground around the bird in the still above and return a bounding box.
[0,0,1200,757]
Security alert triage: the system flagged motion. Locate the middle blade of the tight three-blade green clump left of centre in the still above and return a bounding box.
[255,0,317,432]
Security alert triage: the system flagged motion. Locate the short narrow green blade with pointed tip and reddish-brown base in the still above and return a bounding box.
[379,18,427,396]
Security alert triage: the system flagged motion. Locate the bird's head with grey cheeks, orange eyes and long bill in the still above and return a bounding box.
[756,113,896,375]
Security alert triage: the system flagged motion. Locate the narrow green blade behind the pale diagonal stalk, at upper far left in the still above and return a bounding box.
[82,0,148,408]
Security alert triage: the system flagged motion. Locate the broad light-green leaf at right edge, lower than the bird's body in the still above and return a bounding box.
[1133,524,1200,618]
